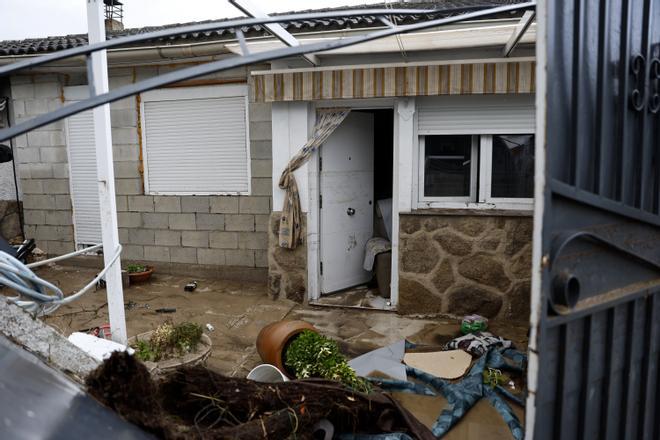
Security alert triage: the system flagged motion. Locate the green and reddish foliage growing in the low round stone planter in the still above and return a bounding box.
[131,322,204,362]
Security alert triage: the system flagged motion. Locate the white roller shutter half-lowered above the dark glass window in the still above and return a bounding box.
[417,95,536,135]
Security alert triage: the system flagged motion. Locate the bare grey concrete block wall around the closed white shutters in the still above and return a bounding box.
[11,66,272,280]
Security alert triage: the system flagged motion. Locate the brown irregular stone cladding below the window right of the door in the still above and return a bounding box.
[398,214,533,320]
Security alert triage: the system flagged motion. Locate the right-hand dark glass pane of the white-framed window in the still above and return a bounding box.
[491,134,534,198]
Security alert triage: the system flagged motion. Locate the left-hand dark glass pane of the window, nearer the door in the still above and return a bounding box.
[424,136,472,197]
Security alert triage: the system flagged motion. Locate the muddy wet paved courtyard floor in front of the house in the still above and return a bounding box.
[18,265,527,440]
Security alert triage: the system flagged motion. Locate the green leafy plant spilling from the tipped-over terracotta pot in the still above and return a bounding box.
[284,330,371,393]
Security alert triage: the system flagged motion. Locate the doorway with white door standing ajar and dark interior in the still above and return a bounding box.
[314,108,394,310]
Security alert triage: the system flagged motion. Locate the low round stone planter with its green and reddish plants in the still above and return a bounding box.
[129,321,211,372]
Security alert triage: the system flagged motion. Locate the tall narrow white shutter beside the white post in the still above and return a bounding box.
[66,111,101,246]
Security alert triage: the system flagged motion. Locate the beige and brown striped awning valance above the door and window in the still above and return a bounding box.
[254,61,536,102]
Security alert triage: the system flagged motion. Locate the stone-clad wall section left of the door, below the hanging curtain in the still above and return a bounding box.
[268,212,307,303]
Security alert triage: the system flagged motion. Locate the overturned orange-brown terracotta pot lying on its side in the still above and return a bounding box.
[257,321,317,377]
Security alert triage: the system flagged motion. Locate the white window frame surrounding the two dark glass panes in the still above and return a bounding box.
[416,129,536,211]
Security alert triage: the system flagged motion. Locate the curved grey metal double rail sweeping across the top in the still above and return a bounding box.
[0,1,536,142]
